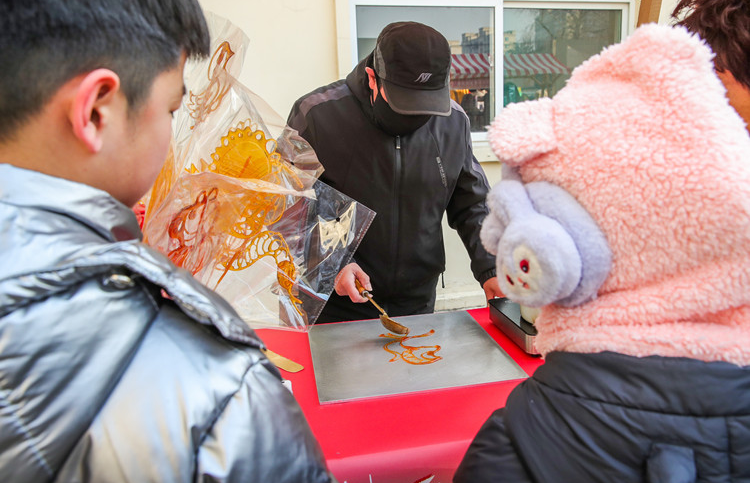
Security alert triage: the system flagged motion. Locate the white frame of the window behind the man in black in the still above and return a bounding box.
[334,0,637,148]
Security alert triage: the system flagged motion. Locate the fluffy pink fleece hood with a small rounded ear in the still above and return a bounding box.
[483,24,750,365]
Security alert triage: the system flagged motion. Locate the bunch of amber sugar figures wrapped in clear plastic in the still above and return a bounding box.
[143,14,375,330]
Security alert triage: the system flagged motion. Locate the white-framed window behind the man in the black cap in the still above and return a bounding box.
[346,0,635,141]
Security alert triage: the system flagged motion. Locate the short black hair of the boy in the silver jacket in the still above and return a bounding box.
[0,0,210,140]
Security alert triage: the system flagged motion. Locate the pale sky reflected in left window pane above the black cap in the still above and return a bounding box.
[357,6,492,41]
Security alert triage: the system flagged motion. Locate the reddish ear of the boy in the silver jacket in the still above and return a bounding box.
[68,69,120,153]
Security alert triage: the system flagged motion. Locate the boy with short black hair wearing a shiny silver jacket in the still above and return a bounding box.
[0,0,333,483]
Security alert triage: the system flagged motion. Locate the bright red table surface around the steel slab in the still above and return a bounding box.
[257,308,543,483]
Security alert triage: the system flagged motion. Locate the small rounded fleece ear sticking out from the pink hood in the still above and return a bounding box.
[488,97,557,166]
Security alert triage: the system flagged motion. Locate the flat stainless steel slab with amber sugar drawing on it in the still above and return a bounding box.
[308,311,528,404]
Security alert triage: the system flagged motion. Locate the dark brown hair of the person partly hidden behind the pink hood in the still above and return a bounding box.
[672,0,750,89]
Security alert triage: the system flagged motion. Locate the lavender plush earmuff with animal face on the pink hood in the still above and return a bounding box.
[481,179,612,307]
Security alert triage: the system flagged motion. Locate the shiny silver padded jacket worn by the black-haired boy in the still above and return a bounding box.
[0,165,332,483]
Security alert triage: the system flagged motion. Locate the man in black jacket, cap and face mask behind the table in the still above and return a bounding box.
[287,22,502,322]
